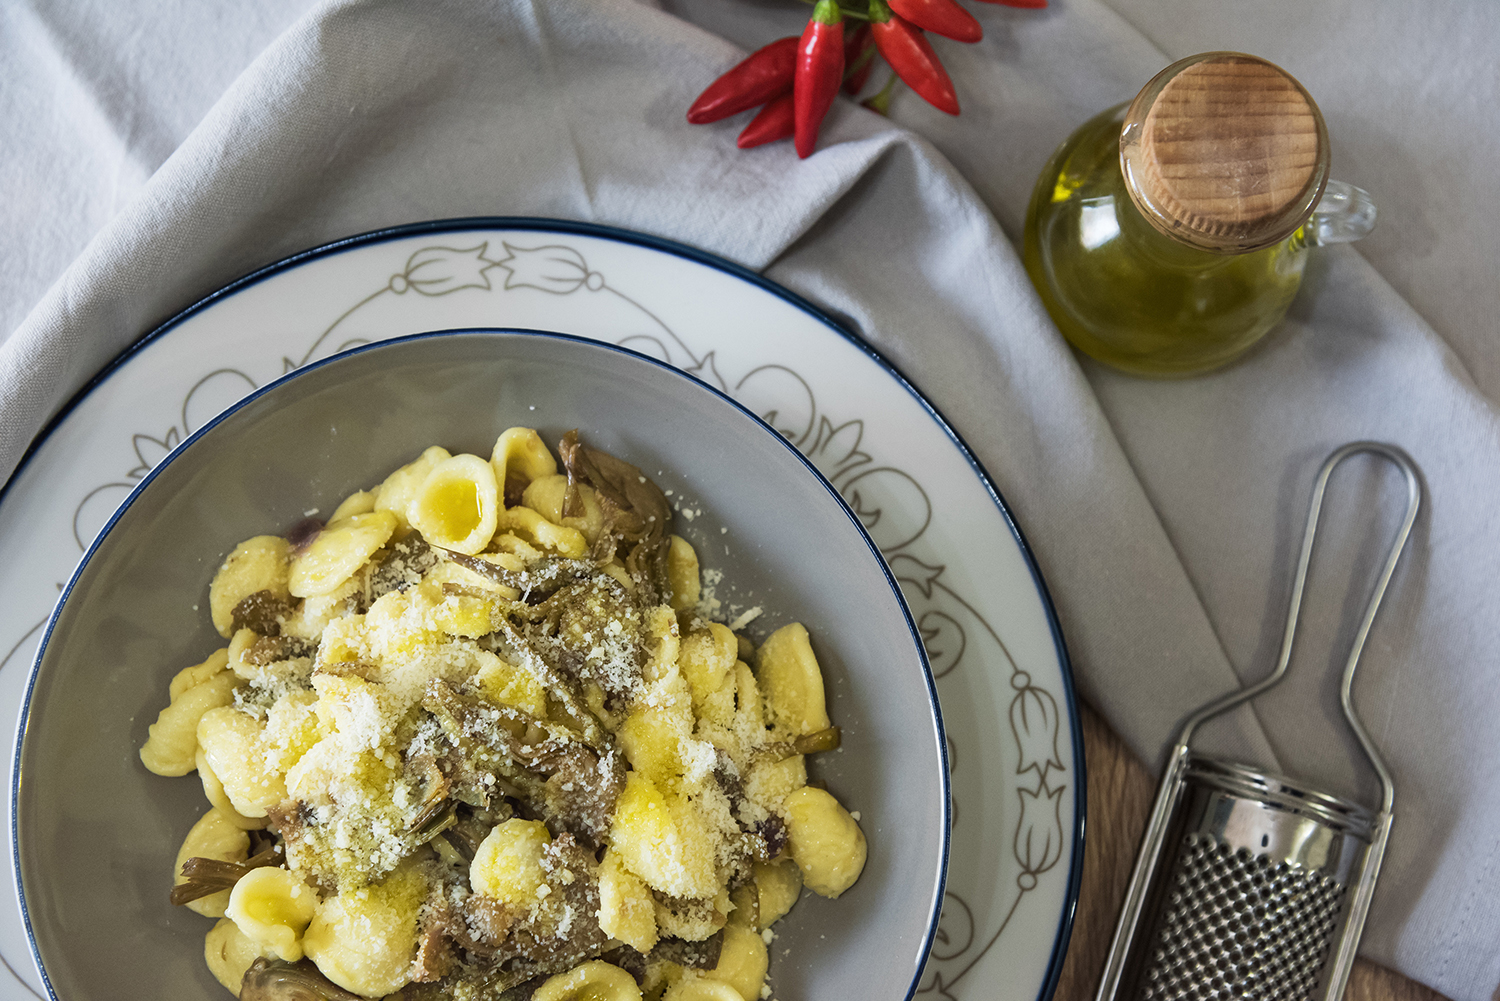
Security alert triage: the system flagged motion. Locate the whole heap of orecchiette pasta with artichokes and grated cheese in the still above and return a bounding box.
[141,428,866,1001]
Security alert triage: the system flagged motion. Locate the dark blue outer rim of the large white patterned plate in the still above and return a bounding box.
[0,216,1088,1001]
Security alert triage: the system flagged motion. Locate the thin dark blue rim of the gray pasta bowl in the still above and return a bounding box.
[0,327,948,1001]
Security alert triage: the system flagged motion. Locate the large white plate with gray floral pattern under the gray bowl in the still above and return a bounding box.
[0,219,1083,1001]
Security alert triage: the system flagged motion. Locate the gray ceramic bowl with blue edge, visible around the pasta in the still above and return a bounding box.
[14,330,948,1001]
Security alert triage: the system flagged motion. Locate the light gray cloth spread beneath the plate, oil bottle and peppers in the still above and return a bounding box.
[0,0,1500,1001]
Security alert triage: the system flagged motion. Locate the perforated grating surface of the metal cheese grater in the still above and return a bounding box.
[1137,833,1346,1001]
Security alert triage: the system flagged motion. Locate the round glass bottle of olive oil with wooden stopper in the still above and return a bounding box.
[1023,53,1374,377]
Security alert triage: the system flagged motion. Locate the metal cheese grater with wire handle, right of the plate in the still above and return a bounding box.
[1097,441,1422,1001]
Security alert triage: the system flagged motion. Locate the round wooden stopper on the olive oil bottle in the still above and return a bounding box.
[1121,53,1328,254]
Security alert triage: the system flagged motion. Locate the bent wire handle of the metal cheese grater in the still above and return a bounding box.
[1172,441,1422,813]
